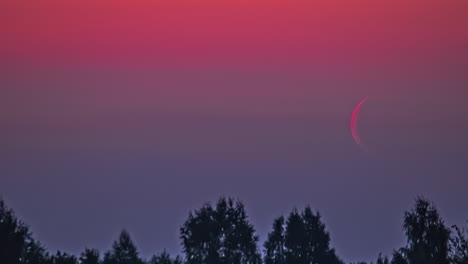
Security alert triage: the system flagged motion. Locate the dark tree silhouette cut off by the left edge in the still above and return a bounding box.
[0,200,29,264]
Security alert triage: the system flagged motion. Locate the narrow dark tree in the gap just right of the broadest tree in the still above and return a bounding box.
[263,216,286,264]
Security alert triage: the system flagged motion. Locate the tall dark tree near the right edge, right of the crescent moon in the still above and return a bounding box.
[403,197,450,264]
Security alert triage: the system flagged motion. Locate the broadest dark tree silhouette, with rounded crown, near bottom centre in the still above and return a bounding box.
[180,198,261,264]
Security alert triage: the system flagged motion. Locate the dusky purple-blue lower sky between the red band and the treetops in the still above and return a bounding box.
[0,64,468,261]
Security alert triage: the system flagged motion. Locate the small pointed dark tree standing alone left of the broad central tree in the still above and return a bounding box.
[103,230,143,264]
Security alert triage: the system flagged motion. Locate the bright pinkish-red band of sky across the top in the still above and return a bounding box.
[0,0,468,67]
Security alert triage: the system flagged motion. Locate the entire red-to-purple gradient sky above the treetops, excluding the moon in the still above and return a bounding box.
[0,0,468,262]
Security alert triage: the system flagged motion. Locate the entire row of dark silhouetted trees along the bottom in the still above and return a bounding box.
[0,197,468,264]
